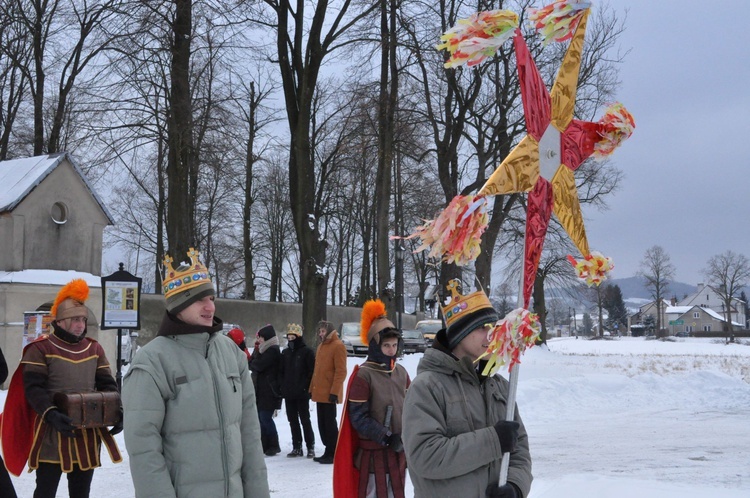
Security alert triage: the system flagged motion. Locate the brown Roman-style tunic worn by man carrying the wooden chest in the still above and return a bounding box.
[21,334,120,472]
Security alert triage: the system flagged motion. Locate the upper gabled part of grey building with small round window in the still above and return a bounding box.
[0,153,113,275]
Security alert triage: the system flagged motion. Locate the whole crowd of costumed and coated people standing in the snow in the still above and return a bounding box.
[0,249,532,498]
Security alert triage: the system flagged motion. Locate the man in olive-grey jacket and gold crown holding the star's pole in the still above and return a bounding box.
[402,281,532,498]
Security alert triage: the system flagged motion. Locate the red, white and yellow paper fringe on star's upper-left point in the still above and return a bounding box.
[435,10,518,68]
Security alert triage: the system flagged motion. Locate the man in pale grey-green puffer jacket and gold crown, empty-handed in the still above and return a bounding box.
[123,249,269,498]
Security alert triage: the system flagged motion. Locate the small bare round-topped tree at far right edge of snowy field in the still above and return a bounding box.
[703,251,750,332]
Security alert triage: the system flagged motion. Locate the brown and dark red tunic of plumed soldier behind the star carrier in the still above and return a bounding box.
[348,361,411,498]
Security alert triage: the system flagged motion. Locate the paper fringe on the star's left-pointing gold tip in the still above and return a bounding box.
[406,195,489,266]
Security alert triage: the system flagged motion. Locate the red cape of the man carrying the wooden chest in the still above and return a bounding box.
[0,335,47,477]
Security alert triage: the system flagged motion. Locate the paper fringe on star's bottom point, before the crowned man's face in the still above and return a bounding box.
[477,308,540,375]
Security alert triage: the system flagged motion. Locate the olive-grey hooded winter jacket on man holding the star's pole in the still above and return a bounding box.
[402,348,532,498]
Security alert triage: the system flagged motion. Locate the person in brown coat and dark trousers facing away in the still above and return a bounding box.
[310,321,346,464]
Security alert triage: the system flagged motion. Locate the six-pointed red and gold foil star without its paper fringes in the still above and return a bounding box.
[479,9,632,308]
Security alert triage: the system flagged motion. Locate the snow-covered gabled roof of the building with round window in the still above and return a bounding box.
[0,152,114,223]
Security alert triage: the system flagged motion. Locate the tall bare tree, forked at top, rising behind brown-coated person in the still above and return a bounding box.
[265,0,377,341]
